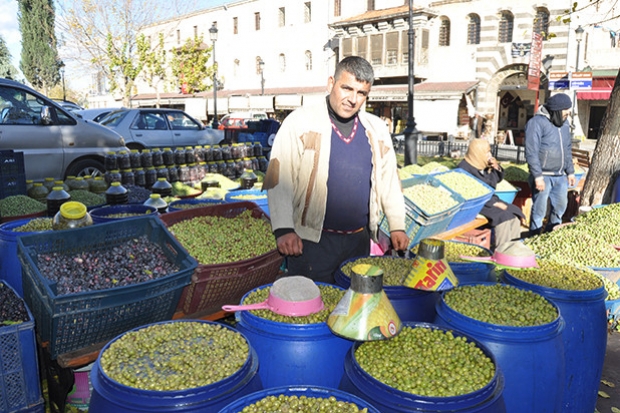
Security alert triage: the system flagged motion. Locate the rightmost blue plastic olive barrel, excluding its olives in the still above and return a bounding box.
[502,271,607,412]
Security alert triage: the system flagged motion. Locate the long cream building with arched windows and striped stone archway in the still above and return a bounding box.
[93,0,620,144]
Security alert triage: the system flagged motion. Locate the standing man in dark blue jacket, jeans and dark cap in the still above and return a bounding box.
[525,93,575,234]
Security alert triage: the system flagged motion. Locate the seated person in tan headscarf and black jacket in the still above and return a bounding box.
[458,139,525,248]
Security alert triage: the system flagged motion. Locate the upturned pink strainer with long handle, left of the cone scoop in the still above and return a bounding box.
[222,275,324,317]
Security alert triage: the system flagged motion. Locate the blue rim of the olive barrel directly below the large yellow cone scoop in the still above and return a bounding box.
[345,322,505,412]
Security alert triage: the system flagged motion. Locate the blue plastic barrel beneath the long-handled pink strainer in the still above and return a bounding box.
[235,283,353,388]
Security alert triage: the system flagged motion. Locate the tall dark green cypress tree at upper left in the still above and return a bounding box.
[18,0,62,91]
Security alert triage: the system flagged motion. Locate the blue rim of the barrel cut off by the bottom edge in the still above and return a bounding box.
[219,386,380,413]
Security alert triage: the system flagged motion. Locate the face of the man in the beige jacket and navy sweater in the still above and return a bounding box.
[327,72,370,119]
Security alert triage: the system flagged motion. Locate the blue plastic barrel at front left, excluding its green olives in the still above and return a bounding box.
[88,320,263,413]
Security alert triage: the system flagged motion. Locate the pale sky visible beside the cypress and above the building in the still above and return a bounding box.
[0,0,233,89]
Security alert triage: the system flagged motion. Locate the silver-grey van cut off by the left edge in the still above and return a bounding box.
[0,78,127,180]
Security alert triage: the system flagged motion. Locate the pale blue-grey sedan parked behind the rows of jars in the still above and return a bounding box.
[100,108,224,150]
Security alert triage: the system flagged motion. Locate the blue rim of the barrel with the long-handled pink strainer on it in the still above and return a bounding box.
[235,282,346,337]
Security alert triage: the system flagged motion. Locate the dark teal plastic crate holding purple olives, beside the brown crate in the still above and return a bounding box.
[17,216,198,359]
